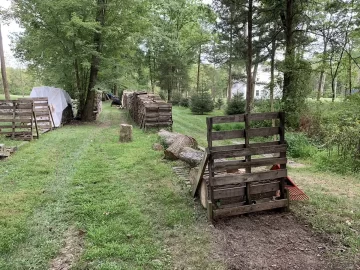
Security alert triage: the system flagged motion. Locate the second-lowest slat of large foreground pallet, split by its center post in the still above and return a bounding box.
[214,181,280,200]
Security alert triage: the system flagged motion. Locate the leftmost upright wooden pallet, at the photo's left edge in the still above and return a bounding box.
[0,100,38,140]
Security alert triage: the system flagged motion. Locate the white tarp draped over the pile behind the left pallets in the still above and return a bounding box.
[30,86,72,127]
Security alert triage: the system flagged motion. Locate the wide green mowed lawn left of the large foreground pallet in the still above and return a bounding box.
[0,103,224,270]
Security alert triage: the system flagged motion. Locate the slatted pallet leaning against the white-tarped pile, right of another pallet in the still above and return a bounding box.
[19,97,55,132]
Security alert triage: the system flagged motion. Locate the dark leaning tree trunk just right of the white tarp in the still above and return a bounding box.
[82,0,107,121]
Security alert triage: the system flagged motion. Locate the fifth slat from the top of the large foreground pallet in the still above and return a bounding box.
[213,169,287,187]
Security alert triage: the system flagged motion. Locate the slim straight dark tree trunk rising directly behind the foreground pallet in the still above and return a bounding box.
[246,0,253,113]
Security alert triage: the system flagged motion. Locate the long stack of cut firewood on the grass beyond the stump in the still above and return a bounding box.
[122,91,172,129]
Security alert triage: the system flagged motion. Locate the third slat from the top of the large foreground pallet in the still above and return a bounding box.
[211,144,287,159]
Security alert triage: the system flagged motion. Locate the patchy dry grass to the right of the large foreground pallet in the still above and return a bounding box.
[289,167,360,254]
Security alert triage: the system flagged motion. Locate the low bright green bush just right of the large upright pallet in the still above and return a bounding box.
[286,133,317,158]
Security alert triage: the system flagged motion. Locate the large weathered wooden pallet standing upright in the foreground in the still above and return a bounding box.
[204,112,289,220]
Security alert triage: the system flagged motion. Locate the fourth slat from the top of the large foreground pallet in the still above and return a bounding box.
[214,157,287,172]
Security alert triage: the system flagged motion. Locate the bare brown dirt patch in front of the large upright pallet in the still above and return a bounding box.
[210,212,359,270]
